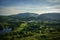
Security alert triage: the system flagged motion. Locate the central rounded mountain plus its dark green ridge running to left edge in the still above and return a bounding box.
[0,13,39,22]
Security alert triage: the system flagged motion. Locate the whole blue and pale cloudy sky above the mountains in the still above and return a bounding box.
[0,0,60,15]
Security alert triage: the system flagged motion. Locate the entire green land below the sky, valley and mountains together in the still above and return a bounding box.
[0,13,60,40]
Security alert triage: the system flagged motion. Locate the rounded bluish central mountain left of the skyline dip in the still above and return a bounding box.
[10,13,39,21]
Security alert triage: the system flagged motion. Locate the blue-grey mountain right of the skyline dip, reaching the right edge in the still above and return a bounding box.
[38,13,60,21]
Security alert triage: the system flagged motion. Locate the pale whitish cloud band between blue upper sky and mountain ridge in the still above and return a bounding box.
[0,5,60,15]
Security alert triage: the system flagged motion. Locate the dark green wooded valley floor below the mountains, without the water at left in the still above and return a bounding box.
[0,20,60,40]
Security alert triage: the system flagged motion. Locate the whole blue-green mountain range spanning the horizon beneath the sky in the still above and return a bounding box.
[0,13,60,21]
